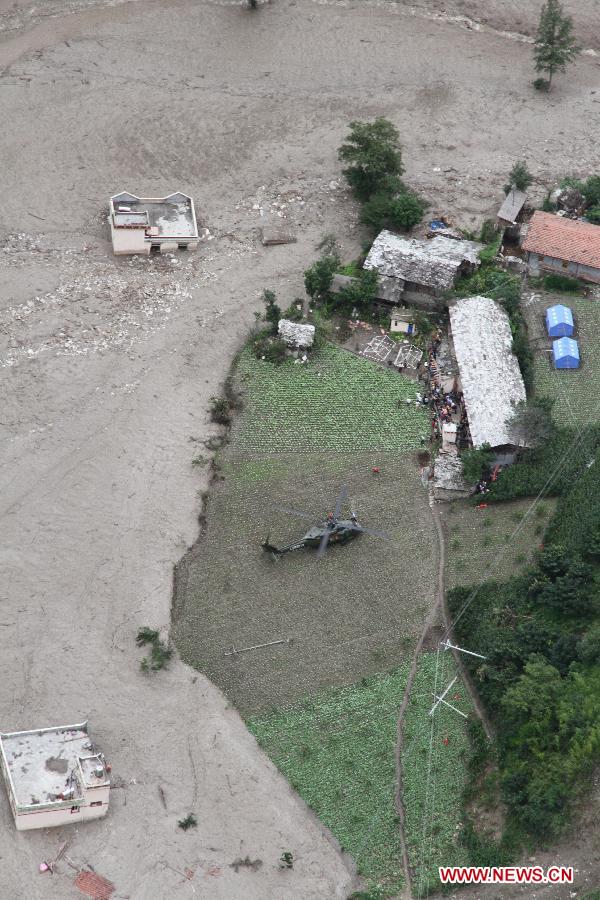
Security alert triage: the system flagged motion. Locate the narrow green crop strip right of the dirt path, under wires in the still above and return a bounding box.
[402,651,471,897]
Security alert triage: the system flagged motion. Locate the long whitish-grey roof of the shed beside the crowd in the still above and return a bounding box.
[449,297,525,447]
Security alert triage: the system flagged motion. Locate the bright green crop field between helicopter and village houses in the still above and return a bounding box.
[235,345,429,453]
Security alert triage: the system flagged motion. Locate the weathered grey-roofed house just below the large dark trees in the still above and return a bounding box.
[364,230,483,309]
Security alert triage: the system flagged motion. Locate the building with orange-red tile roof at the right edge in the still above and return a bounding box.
[521,211,600,284]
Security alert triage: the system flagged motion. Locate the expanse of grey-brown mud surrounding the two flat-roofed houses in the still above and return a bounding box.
[0,0,598,900]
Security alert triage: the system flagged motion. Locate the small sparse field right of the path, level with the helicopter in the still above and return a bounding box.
[442,499,555,590]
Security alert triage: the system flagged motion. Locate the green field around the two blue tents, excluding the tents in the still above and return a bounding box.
[525,295,600,428]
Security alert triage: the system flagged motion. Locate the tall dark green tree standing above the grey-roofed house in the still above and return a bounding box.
[338,117,404,200]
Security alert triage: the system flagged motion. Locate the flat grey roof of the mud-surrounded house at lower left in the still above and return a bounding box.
[0,722,108,806]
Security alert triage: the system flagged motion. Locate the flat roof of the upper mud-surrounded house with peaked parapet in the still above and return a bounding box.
[111,193,198,238]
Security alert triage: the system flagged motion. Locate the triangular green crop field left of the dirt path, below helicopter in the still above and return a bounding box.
[247,665,408,896]
